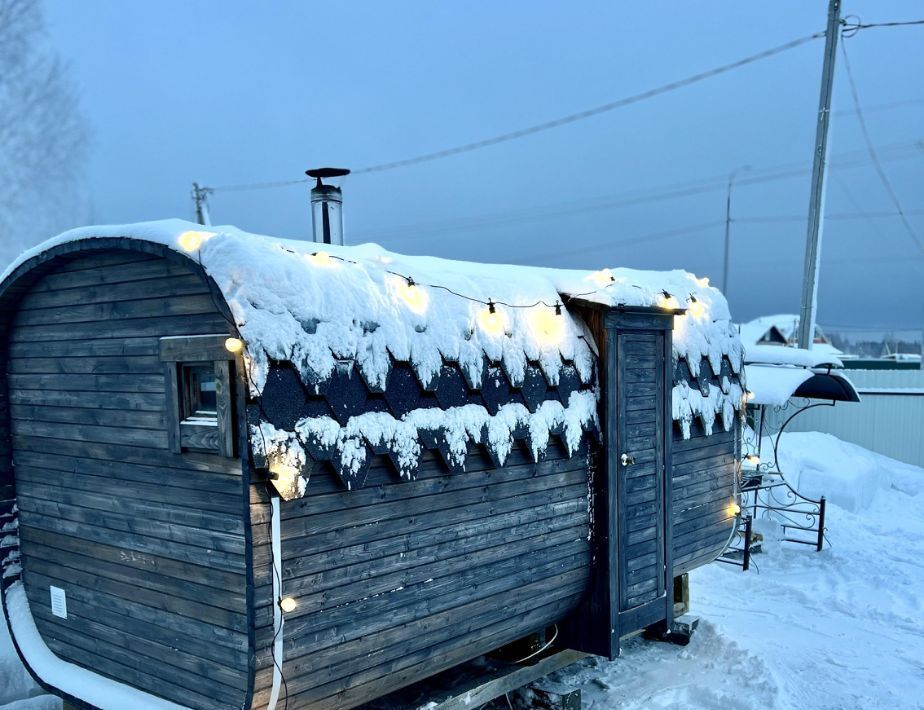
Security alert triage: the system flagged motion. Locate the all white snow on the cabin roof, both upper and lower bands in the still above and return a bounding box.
[0,220,742,495]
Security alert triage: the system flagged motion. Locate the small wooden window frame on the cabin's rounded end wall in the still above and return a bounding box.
[160,334,235,458]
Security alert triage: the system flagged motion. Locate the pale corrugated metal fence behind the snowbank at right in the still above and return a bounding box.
[787,370,924,466]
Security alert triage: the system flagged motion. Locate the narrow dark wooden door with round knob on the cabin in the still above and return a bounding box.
[615,329,673,634]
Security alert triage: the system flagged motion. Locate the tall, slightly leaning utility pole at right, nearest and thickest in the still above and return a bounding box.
[799,0,841,348]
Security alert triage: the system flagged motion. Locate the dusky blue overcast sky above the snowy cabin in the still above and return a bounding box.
[47,0,924,329]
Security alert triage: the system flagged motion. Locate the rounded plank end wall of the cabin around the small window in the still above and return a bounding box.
[7,251,249,708]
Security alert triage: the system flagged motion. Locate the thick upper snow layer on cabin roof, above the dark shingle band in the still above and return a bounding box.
[0,220,741,394]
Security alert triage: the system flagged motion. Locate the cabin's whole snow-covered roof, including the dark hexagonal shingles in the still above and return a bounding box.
[0,220,742,495]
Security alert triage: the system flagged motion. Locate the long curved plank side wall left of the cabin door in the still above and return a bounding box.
[253,444,590,710]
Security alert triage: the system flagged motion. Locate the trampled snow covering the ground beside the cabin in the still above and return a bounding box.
[0,433,924,710]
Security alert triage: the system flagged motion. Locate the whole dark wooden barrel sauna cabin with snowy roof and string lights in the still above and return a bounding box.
[0,221,743,710]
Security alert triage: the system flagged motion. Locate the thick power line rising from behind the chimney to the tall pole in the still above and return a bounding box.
[204,32,824,192]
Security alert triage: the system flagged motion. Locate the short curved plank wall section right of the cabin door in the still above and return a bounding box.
[672,421,738,576]
